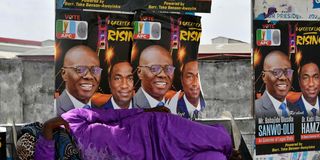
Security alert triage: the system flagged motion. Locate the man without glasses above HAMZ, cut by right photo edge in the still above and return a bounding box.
[295,61,320,116]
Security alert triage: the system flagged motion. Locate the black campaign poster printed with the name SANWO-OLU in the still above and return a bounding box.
[253,20,320,155]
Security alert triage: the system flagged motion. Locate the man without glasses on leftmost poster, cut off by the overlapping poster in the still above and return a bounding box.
[102,61,133,109]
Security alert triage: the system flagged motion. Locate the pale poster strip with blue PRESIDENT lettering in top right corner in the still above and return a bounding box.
[253,0,320,20]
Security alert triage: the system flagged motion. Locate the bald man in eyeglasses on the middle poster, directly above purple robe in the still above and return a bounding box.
[133,45,175,108]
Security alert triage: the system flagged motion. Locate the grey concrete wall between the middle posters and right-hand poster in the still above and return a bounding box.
[199,60,253,118]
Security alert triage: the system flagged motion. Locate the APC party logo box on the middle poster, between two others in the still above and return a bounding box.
[133,21,161,40]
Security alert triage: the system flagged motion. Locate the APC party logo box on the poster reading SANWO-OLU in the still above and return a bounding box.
[256,29,281,46]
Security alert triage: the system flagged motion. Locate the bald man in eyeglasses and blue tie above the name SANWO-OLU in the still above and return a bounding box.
[255,50,301,117]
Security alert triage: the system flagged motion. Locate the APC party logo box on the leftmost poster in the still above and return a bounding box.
[56,19,88,40]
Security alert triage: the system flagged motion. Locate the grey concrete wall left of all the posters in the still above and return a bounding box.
[0,59,54,124]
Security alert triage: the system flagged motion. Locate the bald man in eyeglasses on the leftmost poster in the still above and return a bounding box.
[56,45,102,116]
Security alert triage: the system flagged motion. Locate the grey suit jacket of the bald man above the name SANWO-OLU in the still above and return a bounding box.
[255,92,301,117]
